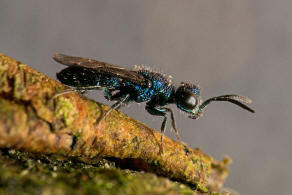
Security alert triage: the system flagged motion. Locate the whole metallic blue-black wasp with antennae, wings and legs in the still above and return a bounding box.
[53,54,254,149]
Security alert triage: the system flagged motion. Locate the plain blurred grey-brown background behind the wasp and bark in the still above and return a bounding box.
[0,0,292,195]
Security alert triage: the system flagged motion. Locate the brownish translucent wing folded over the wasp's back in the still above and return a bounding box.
[53,53,147,85]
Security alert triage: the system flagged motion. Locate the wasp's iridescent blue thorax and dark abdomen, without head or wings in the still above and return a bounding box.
[57,66,175,106]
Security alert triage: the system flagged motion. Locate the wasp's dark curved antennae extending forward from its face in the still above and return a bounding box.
[199,95,255,113]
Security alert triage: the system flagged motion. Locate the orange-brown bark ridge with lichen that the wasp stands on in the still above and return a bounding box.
[0,54,228,192]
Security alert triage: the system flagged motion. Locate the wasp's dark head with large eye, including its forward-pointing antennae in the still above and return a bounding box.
[175,82,255,119]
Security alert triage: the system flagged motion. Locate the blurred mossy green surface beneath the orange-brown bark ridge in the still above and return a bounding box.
[0,149,208,195]
